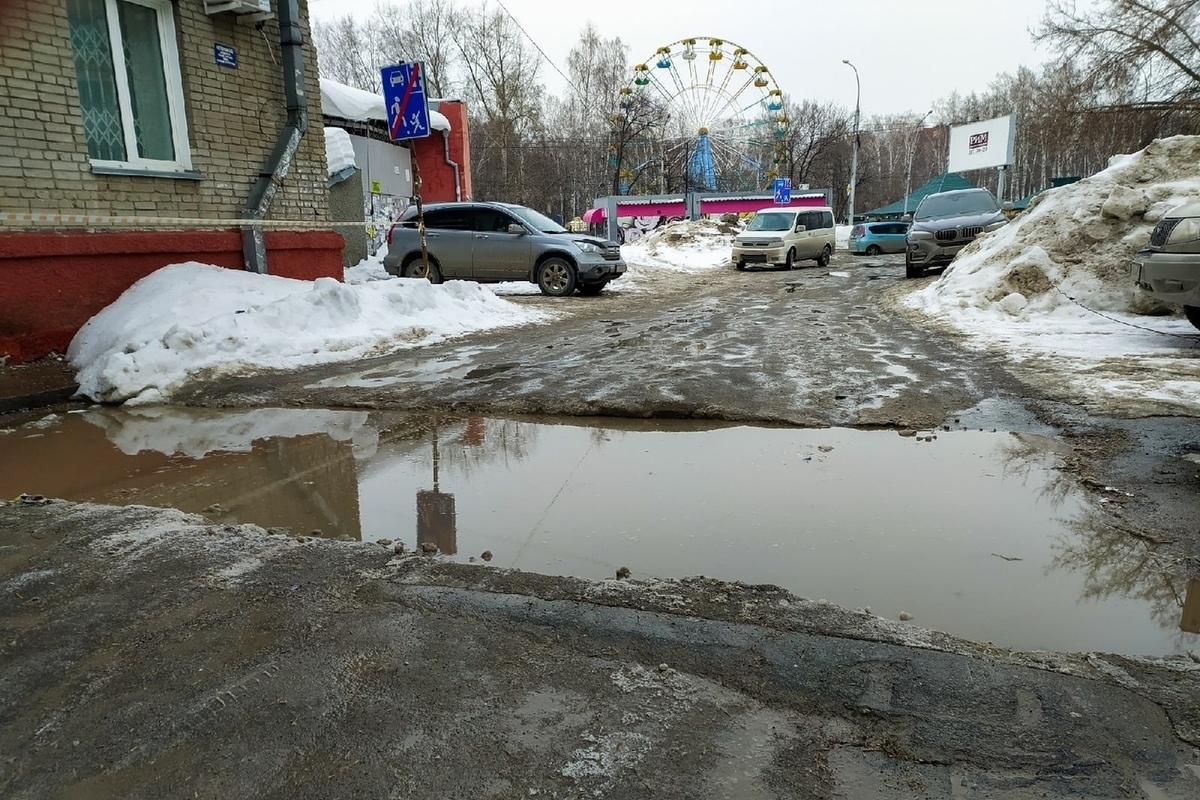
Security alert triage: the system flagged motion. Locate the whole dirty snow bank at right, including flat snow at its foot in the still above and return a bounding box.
[904,137,1200,416]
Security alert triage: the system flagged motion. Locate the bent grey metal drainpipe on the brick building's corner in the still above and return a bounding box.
[241,0,308,275]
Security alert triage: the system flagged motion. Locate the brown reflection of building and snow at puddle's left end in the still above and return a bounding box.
[0,409,370,540]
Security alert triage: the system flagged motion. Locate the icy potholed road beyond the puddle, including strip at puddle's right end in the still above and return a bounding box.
[179,252,1200,561]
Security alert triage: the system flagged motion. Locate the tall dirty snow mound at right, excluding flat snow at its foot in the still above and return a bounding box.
[908,136,1200,321]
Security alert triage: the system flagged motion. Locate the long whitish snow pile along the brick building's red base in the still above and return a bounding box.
[67,261,548,404]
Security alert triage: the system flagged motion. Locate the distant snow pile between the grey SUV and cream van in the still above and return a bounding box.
[620,219,738,279]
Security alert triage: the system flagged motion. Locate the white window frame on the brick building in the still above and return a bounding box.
[91,0,192,173]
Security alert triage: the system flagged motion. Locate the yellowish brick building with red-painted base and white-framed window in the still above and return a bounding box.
[0,0,342,361]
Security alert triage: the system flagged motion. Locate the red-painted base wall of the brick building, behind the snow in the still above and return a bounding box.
[0,230,343,361]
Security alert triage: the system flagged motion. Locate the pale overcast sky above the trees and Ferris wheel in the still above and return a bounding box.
[308,0,1088,119]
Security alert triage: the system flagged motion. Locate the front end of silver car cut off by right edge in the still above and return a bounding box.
[1133,203,1200,327]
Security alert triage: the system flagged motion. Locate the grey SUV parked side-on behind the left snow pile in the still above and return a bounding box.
[383,203,626,297]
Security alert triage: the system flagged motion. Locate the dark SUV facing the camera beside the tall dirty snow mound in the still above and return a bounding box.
[904,188,1008,278]
